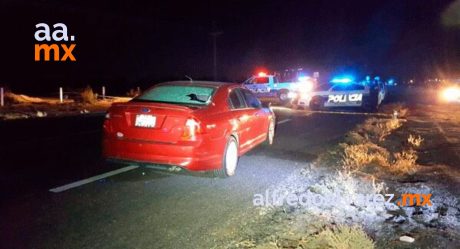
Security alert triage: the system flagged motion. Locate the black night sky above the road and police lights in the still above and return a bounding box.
[0,0,460,93]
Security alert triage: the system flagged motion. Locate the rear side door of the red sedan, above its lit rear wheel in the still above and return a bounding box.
[228,88,254,153]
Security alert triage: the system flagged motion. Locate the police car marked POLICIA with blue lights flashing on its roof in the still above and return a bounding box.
[297,76,386,110]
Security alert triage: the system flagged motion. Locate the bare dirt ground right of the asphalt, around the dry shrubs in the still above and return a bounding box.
[222,105,460,248]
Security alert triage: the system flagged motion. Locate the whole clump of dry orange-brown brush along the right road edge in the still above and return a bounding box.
[320,103,424,176]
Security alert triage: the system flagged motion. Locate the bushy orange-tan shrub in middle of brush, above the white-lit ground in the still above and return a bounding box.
[342,142,389,171]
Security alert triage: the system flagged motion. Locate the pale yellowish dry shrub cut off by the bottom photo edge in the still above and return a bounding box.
[303,225,375,249]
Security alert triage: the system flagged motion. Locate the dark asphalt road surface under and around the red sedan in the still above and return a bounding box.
[0,108,366,248]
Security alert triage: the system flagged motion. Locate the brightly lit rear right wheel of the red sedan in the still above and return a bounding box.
[214,136,238,178]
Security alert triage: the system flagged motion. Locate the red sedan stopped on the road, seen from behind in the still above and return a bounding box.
[103,81,275,176]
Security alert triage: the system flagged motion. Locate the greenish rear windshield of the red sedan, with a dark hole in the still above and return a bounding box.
[134,85,215,105]
